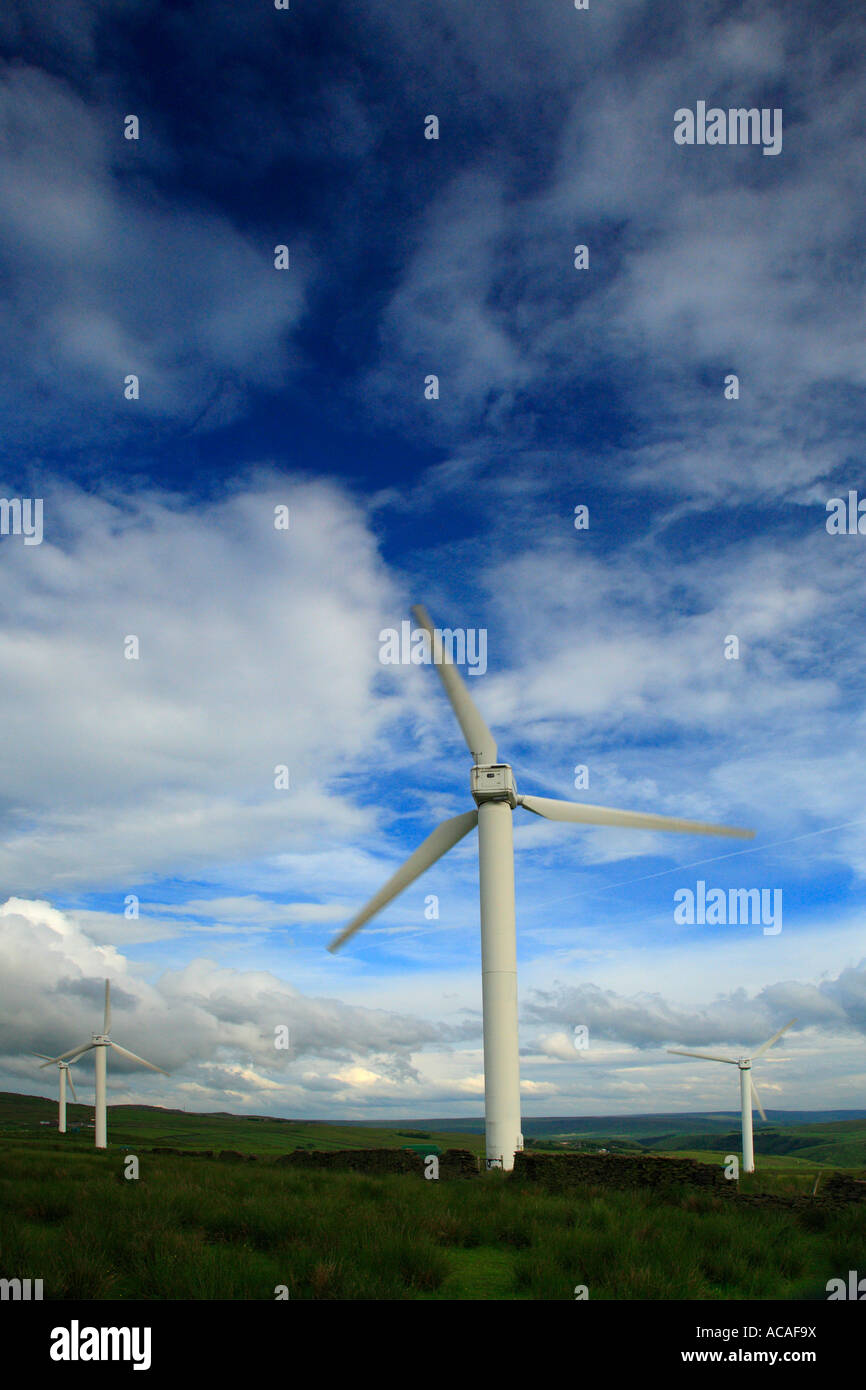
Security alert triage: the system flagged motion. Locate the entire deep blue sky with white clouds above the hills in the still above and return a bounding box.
[0,0,866,1120]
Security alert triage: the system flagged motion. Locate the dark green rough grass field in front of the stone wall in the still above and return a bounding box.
[0,1138,866,1301]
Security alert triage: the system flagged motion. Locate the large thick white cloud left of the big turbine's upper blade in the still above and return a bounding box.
[0,477,403,889]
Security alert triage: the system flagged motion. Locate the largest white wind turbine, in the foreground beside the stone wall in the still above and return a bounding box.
[328,606,755,1169]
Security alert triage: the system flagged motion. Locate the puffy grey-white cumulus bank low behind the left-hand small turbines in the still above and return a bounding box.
[0,899,438,1104]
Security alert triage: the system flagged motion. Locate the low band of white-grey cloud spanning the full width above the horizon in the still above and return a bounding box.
[0,899,866,1119]
